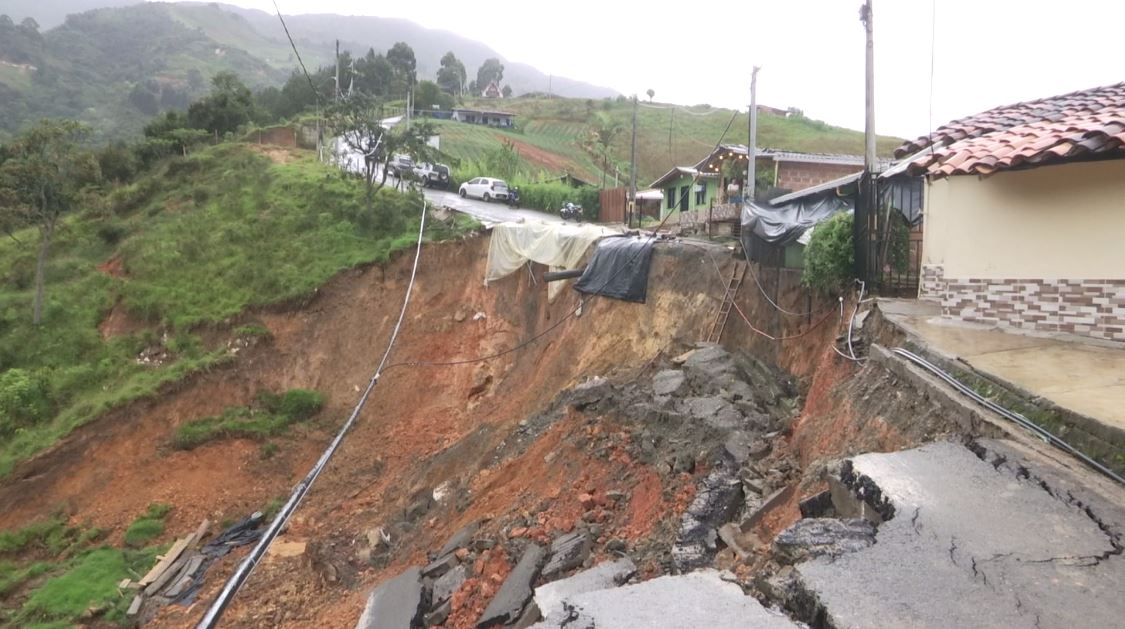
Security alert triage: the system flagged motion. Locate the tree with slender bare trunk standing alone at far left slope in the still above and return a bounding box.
[0,119,100,325]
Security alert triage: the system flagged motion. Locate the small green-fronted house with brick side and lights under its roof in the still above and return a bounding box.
[649,144,890,219]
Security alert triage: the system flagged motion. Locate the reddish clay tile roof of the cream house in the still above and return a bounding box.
[894,83,1125,177]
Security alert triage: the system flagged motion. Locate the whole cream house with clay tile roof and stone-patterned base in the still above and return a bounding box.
[898,83,1125,341]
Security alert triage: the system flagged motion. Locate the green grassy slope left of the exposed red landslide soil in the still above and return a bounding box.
[0,144,436,476]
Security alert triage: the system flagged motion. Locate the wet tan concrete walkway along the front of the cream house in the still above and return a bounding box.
[879,300,1125,430]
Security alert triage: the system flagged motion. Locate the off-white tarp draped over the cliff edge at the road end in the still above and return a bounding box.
[485,223,618,299]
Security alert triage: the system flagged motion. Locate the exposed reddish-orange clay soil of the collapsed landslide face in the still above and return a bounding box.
[0,237,721,627]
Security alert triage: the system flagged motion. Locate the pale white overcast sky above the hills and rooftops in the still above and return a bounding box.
[166,0,1125,137]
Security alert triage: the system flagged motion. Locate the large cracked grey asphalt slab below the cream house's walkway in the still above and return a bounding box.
[797,443,1125,629]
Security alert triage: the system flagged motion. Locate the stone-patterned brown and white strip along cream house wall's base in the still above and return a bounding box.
[919,264,1125,341]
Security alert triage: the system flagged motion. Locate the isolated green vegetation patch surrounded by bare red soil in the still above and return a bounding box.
[172,389,324,450]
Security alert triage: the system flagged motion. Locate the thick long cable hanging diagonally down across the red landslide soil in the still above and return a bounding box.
[196,198,426,629]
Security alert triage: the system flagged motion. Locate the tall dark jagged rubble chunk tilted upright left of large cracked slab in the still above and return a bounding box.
[672,466,743,573]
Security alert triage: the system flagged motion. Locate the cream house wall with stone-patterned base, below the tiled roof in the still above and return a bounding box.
[919,160,1125,341]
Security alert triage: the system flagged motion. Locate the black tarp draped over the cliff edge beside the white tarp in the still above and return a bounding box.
[574,236,655,304]
